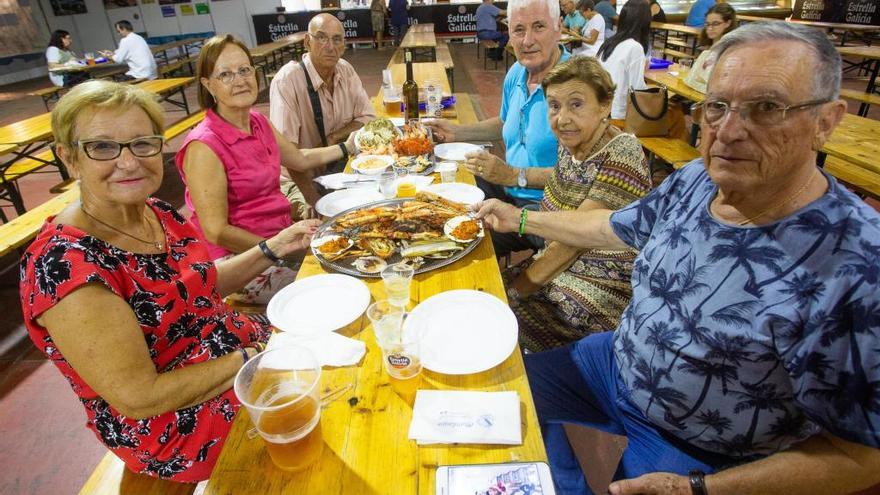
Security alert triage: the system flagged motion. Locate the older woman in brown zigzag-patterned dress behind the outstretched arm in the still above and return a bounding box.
[505,57,651,351]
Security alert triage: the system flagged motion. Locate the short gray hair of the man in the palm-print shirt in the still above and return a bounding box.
[712,21,842,100]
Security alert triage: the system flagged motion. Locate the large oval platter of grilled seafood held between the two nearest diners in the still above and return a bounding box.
[311,192,484,277]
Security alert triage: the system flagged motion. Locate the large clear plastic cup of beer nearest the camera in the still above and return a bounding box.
[234,346,324,471]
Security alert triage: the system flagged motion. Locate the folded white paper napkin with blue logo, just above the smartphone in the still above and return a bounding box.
[409,390,522,445]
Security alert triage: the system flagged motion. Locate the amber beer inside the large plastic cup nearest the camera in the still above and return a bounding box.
[257,395,324,471]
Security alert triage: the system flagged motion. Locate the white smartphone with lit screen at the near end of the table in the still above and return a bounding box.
[435,462,556,495]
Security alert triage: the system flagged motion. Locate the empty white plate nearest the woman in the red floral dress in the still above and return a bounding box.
[266,273,370,335]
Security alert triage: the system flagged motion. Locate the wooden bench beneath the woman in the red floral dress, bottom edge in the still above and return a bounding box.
[79,452,196,495]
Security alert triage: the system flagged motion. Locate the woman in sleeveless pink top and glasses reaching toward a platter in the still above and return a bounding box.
[175,34,354,304]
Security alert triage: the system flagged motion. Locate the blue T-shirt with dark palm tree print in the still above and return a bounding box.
[611,165,880,457]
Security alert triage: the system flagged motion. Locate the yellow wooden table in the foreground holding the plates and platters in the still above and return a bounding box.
[204,93,547,495]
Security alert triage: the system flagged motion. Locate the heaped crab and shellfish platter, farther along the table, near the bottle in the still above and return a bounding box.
[352,118,435,175]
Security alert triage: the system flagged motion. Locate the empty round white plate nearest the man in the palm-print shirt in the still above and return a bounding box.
[404,290,518,375]
